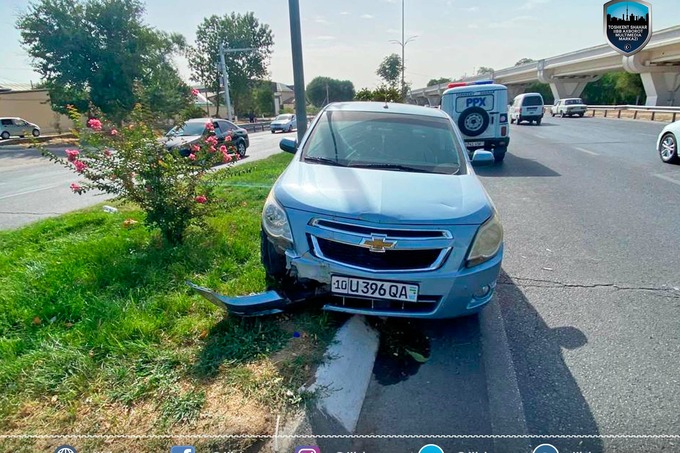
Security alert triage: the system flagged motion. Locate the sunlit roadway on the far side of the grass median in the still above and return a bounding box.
[0,132,295,230]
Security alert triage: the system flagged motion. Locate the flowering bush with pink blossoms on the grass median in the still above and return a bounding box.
[42,105,238,244]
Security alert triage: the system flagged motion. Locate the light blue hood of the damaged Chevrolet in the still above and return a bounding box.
[274,161,493,225]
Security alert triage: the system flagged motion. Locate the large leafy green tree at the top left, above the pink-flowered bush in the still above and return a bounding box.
[17,0,189,122]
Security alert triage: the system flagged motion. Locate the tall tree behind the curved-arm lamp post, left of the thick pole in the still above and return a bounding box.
[188,12,274,115]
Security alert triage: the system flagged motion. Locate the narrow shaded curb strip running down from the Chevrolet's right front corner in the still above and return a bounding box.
[479,298,531,452]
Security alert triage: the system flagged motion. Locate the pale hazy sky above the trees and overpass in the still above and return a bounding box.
[0,0,680,90]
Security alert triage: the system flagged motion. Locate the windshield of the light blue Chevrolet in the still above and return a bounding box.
[303,111,463,174]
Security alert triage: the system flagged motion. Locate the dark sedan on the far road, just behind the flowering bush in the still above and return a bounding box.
[165,118,250,157]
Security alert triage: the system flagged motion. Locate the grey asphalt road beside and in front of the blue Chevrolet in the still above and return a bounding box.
[347,118,680,453]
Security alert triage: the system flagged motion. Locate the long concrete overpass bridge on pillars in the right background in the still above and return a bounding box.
[410,25,680,106]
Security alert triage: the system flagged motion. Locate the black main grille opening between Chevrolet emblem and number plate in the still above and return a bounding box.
[316,238,442,271]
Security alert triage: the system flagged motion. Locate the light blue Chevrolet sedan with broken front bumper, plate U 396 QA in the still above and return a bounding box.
[189,102,503,319]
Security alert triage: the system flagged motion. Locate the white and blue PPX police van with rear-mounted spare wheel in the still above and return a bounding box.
[441,80,510,162]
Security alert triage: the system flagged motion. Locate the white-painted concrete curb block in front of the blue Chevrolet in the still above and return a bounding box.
[269,316,380,452]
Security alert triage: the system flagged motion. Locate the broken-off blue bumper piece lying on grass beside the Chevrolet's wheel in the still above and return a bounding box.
[187,281,291,316]
